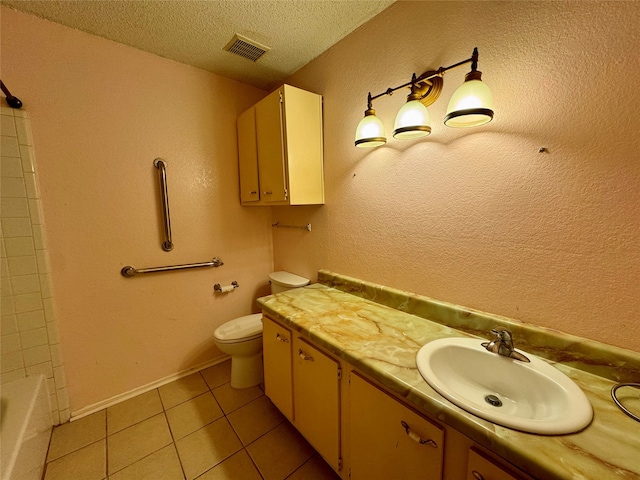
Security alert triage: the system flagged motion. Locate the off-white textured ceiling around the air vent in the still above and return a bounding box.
[0,0,393,90]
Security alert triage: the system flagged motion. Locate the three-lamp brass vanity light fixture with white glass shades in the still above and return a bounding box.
[355,48,493,148]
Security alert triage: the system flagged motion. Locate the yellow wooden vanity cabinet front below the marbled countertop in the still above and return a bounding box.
[262,316,534,480]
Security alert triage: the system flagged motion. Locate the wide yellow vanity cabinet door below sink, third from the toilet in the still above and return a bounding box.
[349,372,444,480]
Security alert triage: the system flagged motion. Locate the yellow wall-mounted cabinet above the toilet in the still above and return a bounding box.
[237,85,324,206]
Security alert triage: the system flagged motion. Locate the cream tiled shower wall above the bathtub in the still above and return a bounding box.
[0,106,70,424]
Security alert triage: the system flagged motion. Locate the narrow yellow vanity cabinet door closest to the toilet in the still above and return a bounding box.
[262,316,293,420]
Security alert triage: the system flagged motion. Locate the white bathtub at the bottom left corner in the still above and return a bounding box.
[0,375,52,480]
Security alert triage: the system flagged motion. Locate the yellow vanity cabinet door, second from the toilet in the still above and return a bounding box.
[293,337,341,472]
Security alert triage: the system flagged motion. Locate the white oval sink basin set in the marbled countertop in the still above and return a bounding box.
[416,338,593,435]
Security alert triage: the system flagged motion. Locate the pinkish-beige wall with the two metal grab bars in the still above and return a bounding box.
[2,8,273,412]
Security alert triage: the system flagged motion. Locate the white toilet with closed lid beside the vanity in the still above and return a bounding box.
[213,271,309,388]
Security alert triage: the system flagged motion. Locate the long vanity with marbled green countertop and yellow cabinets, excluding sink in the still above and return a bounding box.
[259,272,640,480]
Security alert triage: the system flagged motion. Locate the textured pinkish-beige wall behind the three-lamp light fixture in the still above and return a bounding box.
[273,2,640,351]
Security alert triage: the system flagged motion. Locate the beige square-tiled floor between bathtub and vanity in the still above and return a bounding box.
[43,361,339,480]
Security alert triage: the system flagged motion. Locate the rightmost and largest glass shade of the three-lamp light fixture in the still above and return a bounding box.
[444,72,493,127]
